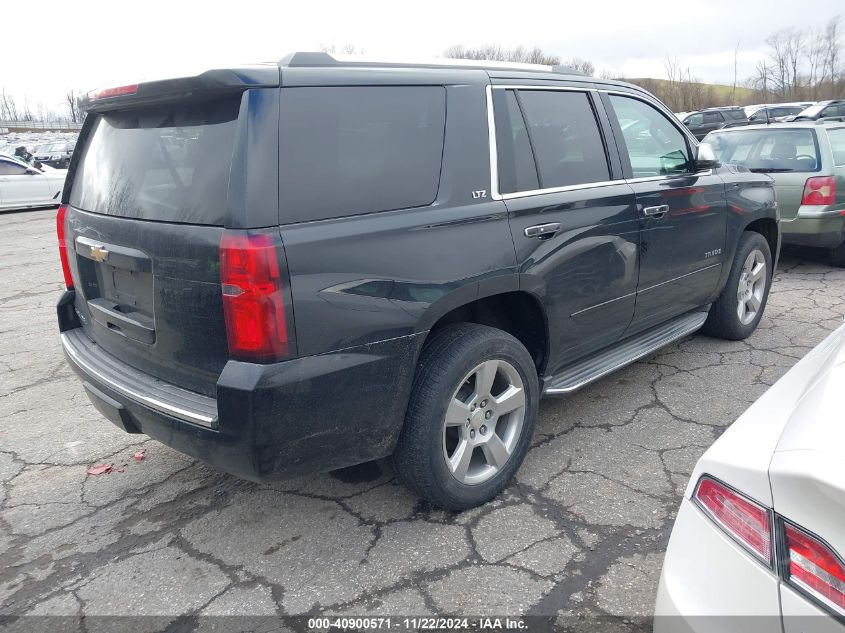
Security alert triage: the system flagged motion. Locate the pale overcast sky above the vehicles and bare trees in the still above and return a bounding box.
[0,0,845,108]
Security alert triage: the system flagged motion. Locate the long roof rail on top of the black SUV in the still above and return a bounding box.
[278,51,584,76]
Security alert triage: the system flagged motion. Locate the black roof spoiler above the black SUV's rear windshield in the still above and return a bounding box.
[79,65,279,112]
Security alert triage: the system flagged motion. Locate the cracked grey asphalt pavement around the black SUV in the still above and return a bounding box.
[0,212,845,620]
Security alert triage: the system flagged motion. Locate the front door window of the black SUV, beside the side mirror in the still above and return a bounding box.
[610,95,690,178]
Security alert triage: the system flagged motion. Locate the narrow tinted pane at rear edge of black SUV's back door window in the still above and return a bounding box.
[494,90,540,193]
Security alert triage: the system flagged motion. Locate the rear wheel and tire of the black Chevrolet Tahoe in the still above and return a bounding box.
[393,323,540,510]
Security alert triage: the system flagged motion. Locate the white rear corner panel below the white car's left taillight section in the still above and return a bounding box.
[654,499,781,633]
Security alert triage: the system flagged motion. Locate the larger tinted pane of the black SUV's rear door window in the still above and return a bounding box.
[519,90,610,189]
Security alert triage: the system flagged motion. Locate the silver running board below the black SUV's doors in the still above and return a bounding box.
[543,312,707,395]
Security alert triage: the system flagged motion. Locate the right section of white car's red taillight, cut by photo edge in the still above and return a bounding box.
[784,524,845,615]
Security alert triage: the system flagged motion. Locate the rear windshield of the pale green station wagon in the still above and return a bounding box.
[705,127,821,173]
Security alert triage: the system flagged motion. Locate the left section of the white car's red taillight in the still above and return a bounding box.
[695,477,772,565]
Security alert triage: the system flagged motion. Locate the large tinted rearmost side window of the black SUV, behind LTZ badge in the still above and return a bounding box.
[279,86,446,222]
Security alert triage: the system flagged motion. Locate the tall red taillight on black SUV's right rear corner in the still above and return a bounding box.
[220,231,289,361]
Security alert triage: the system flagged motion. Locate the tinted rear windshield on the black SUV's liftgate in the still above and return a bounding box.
[70,98,240,225]
